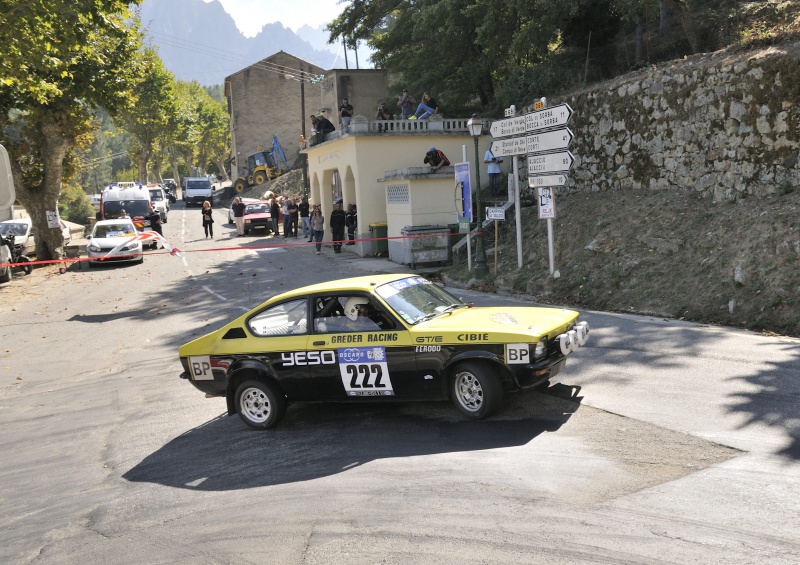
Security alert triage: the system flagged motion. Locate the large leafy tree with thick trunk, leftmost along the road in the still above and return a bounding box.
[0,0,140,260]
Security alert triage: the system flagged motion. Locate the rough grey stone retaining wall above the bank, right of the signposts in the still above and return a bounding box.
[551,44,800,201]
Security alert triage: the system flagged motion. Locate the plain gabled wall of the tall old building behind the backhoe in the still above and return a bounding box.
[225,51,325,177]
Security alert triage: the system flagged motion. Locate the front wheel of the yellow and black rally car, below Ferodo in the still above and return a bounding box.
[450,362,503,420]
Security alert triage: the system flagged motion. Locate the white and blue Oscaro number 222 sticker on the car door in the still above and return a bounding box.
[337,346,394,396]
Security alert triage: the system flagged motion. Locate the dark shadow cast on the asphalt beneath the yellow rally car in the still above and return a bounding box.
[123,385,581,491]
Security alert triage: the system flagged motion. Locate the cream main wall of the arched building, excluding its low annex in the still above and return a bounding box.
[306,131,482,255]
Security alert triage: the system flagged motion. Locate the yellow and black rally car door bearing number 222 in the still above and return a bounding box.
[309,292,425,401]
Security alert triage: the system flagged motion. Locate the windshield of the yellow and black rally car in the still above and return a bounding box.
[375,277,466,324]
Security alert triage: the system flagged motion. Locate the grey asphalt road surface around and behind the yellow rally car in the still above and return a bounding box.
[0,203,800,564]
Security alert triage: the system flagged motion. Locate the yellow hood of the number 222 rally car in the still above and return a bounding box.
[413,306,578,337]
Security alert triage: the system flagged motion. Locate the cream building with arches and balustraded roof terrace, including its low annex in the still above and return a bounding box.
[304,115,484,264]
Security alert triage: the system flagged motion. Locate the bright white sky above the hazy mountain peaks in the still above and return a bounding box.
[205,0,347,37]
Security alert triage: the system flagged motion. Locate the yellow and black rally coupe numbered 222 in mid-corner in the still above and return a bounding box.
[179,275,589,429]
